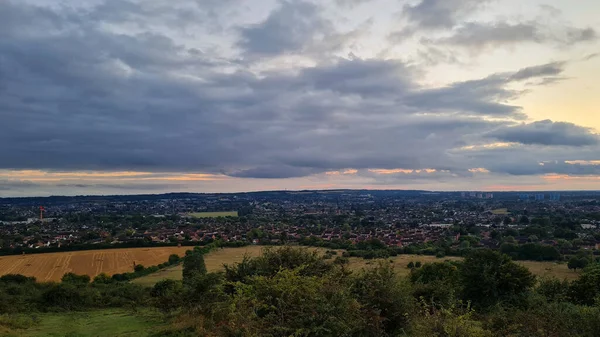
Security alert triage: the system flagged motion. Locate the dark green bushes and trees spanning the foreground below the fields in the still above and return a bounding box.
[0,247,600,337]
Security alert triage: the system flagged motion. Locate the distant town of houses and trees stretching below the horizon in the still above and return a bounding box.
[0,190,600,260]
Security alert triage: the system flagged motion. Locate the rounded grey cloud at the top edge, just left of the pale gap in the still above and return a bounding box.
[238,0,328,55]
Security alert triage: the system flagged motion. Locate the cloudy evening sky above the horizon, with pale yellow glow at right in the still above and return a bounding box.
[0,0,600,197]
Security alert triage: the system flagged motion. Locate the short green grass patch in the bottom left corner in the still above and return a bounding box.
[0,309,165,337]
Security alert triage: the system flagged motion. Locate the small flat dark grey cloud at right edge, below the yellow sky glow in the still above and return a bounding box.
[488,120,600,146]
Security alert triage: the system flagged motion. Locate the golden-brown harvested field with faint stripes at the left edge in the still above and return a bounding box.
[0,247,191,282]
